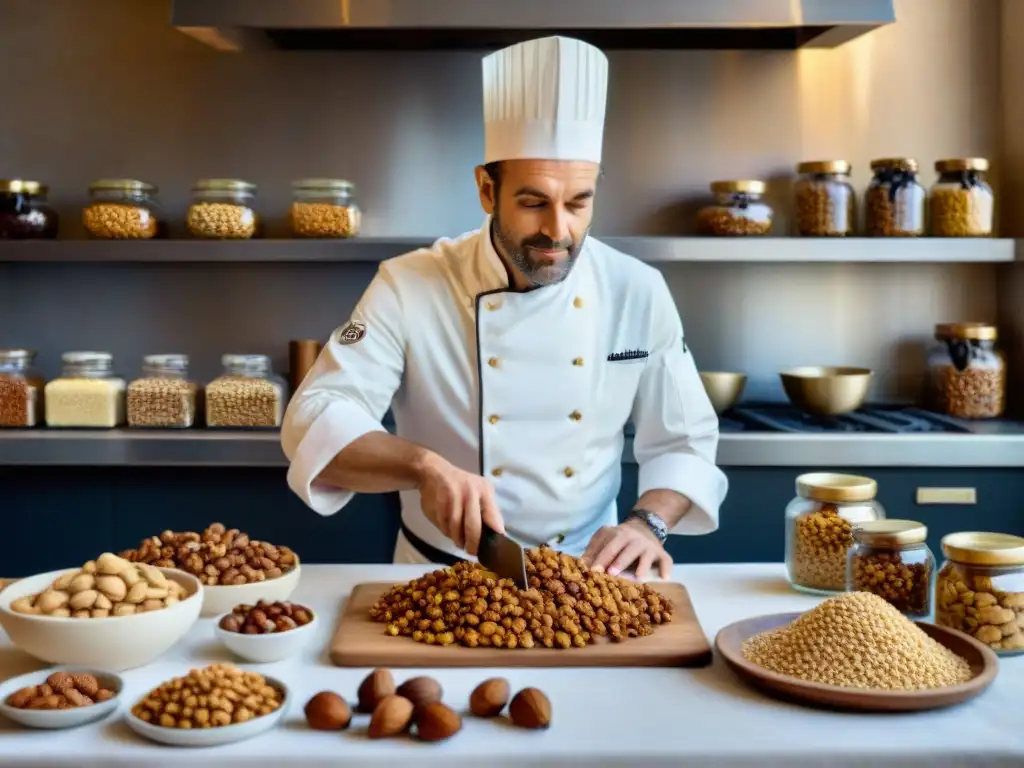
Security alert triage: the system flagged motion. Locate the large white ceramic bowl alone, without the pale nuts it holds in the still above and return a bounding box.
[0,568,203,672]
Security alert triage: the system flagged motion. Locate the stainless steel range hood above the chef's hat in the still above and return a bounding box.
[171,0,896,51]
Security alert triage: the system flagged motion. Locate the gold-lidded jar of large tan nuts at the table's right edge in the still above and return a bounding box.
[935,531,1024,655]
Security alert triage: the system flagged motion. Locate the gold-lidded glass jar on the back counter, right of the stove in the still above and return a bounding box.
[928,323,1007,419]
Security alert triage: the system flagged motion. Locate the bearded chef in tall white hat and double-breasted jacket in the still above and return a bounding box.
[282,37,727,579]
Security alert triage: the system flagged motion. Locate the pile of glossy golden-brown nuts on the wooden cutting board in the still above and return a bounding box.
[370,547,673,648]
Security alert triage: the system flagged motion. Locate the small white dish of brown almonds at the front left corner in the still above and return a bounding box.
[0,668,124,729]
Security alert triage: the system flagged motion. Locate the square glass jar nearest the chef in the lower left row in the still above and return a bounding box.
[206,354,285,428]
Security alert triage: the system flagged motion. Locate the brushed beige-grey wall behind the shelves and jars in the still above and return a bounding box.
[0,0,1003,398]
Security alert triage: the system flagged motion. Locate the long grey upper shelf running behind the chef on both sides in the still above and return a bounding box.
[0,237,1011,264]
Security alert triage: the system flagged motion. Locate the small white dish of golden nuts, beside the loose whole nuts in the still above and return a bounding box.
[125,664,291,746]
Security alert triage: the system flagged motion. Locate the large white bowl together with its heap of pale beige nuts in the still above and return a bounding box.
[0,552,203,672]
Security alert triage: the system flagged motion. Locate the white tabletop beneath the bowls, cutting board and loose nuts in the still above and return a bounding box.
[0,564,1024,768]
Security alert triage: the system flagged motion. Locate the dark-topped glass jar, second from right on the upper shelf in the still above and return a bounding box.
[864,158,928,238]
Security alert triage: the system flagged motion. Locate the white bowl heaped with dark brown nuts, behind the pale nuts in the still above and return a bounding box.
[121,522,300,617]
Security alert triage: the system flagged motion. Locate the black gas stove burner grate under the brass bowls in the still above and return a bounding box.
[721,403,970,434]
